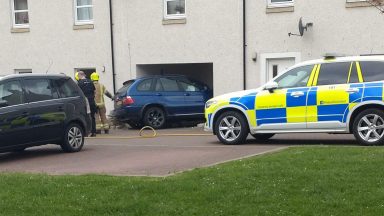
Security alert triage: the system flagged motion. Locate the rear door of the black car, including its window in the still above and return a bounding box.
[23,78,65,142]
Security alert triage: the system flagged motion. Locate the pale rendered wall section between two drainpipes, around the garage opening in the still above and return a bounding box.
[113,0,243,95]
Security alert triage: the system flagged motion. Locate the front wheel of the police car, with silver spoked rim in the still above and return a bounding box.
[215,111,249,145]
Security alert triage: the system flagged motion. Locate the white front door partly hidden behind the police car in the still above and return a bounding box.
[266,58,295,82]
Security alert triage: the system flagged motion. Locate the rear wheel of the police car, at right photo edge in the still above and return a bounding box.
[353,109,384,145]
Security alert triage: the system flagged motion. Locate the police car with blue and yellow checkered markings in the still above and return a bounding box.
[205,55,384,145]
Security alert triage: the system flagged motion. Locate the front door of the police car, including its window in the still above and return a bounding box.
[256,65,315,131]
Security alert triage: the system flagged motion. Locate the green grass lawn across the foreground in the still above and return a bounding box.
[0,147,384,215]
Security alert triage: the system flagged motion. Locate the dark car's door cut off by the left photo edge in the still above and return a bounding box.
[0,80,31,147]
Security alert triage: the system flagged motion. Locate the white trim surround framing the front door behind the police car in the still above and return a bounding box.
[260,52,301,86]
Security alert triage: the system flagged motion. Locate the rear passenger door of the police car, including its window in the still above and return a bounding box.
[307,62,363,130]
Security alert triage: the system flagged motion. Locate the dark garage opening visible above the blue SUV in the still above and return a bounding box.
[136,63,213,90]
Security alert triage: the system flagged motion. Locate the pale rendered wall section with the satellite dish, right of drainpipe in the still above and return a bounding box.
[247,0,384,88]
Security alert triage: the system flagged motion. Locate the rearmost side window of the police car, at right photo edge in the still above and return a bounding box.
[360,61,384,82]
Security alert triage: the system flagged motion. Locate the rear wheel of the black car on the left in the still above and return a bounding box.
[61,123,84,153]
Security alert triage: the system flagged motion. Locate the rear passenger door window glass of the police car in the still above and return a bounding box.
[317,62,351,85]
